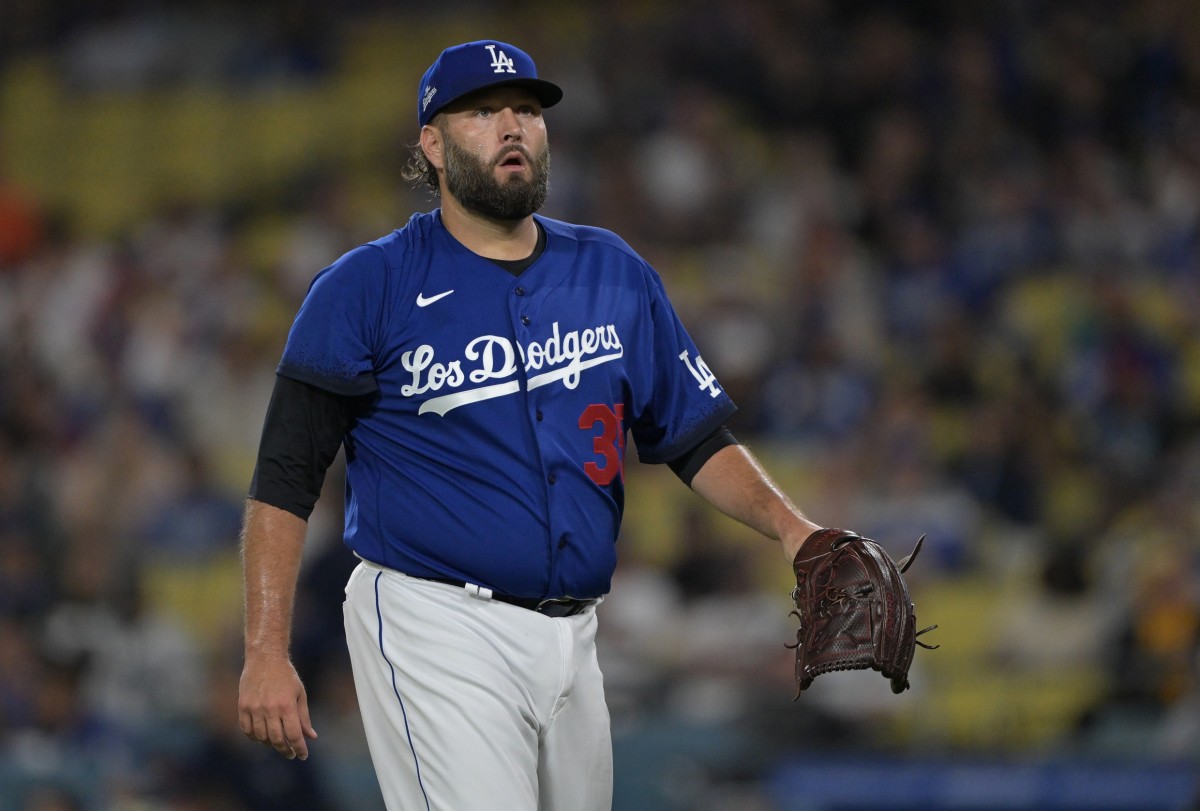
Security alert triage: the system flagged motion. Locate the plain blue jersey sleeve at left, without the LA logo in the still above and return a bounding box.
[277,246,388,396]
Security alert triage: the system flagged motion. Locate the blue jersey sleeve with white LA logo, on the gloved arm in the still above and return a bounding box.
[630,270,737,464]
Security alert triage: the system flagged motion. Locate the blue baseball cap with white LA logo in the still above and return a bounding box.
[416,40,563,127]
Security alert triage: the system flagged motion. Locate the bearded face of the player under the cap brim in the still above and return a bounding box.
[443,88,550,221]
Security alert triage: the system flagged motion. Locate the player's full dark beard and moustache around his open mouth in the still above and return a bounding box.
[445,138,550,221]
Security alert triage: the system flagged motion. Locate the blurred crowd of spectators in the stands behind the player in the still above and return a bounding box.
[0,0,1200,811]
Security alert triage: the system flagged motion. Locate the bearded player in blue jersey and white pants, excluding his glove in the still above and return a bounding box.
[239,41,818,811]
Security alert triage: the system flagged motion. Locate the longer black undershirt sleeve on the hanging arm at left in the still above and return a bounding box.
[250,374,355,521]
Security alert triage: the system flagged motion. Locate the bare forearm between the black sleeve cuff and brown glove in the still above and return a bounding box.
[691,445,821,559]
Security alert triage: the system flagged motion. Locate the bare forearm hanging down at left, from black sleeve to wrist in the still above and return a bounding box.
[241,499,308,657]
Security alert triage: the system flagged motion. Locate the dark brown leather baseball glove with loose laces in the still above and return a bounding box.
[787,529,937,698]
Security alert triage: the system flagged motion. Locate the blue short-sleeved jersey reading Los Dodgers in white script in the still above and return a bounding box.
[278,211,736,597]
